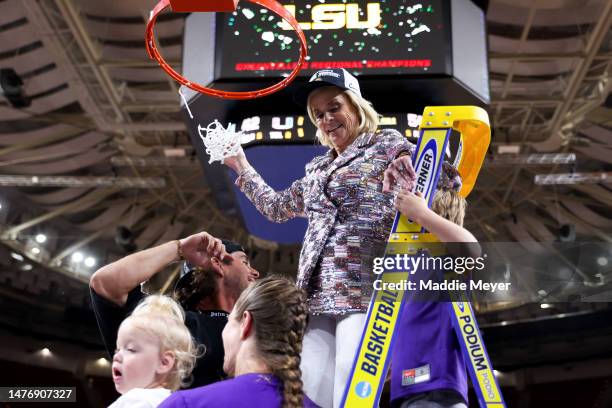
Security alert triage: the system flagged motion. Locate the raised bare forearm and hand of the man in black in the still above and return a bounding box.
[89,232,227,306]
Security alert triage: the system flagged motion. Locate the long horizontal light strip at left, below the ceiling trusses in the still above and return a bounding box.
[0,175,166,188]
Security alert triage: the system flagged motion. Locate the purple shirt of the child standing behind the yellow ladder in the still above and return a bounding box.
[391,301,467,403]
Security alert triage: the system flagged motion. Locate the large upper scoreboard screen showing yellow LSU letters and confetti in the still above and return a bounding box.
[215,0,451,79]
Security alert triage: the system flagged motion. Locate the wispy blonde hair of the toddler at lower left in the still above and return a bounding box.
[122,295,202,391]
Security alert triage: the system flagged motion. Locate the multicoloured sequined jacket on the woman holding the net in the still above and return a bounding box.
[236,129,414,314]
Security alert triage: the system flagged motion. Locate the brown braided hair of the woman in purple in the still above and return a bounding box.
[234,276,308,408]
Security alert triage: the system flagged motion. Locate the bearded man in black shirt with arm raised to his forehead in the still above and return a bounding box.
[89,232,259,387]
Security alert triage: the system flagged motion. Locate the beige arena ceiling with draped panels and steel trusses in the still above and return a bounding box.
[0,0,612,290]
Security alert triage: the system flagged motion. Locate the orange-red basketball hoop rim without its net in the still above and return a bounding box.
[145,0,308,99]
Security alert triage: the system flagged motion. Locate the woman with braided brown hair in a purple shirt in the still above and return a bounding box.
[160,276,316,408]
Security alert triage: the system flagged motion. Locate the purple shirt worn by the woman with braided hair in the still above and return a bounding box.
[158,374,317,408]
